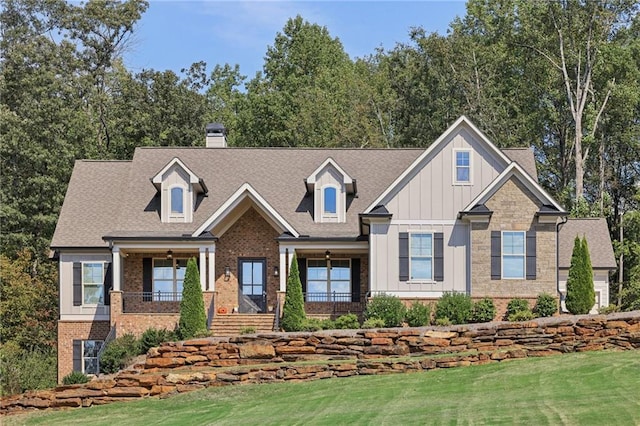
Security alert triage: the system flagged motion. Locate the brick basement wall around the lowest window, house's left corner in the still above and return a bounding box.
[58,321,110,382]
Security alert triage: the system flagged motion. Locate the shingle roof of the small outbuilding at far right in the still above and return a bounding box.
[559,218,617,269]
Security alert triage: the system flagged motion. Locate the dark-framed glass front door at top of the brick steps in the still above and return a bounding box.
[238,258,267,313]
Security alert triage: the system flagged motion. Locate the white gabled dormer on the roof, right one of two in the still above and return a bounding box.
[305,158,357,223]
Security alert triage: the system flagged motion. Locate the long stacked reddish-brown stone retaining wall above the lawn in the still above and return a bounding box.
[0,311,640,413]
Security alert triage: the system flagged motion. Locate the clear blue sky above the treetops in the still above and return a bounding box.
[124,0,465,78]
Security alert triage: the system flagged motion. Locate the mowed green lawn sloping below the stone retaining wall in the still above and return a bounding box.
[3,351,640,426]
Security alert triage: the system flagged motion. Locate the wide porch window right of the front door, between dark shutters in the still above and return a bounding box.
[306,259,351,302]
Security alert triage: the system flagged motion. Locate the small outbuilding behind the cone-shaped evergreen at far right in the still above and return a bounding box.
[558,218,618,314]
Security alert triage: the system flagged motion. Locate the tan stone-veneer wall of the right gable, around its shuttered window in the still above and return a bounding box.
[471,178,557,298]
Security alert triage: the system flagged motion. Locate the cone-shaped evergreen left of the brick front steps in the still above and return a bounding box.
[178,258,207,339]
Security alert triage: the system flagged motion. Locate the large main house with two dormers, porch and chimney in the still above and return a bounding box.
[51,117,606,378]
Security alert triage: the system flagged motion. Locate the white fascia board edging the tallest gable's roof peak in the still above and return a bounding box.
[364,115,511,213]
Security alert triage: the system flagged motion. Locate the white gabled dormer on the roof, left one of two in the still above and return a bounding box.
[151,157,207,223]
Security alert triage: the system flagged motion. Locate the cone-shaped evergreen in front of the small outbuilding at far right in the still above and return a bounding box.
[565,236,595,315]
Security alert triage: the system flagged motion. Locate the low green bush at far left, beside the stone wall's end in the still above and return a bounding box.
[0,342,57,396]
